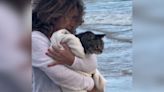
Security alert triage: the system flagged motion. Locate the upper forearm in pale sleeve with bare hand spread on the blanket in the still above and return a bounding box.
[47,43,97,73]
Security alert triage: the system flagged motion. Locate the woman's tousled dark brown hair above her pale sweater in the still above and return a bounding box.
[32,0,84,37]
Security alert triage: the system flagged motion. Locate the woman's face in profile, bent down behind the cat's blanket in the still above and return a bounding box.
[56,9,84,34]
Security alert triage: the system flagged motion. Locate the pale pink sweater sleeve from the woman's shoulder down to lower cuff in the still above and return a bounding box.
[32,32,94,90]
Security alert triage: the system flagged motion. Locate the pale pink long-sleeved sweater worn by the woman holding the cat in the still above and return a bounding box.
[32,31,97,92]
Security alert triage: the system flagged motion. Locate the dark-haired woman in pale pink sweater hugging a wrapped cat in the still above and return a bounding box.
[32,0,96,92]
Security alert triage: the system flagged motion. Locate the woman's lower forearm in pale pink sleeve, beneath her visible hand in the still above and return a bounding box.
[41,65,94,91]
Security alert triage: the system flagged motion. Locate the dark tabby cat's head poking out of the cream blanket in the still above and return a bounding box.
[76,31,105,54]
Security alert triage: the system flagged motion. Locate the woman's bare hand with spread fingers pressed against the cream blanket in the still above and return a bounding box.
[46,43,75,67]
